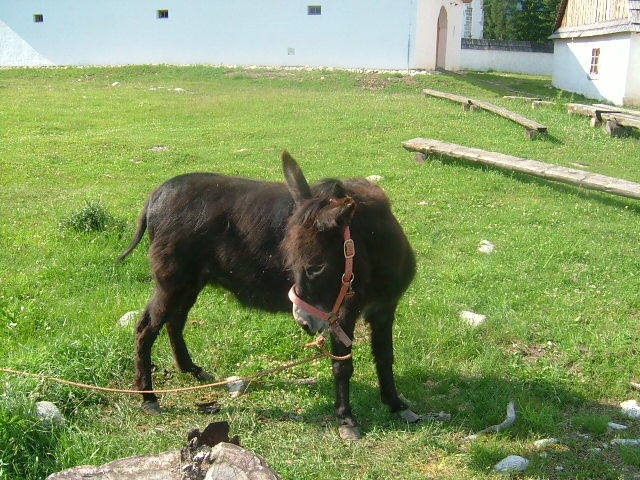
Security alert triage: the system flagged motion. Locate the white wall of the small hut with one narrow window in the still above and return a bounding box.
[553,33,640,105]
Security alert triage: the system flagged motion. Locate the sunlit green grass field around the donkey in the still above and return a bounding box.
[0,66,640,480]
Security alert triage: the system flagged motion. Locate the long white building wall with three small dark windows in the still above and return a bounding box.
[0,0,420,69]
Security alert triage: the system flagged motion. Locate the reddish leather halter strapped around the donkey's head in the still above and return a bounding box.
[289,226,356,347]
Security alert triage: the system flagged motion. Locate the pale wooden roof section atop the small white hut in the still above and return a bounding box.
[549,0,640,38]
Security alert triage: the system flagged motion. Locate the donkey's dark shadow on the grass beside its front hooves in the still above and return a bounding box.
[246,365,622,479]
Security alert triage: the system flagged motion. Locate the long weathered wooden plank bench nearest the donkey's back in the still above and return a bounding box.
[402,138,640,199]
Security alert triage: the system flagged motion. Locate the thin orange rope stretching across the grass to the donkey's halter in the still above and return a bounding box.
[0,337,352,394]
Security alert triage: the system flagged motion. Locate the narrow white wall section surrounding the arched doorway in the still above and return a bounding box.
[411,0,464,71]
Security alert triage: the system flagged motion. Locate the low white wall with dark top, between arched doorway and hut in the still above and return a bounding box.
[460,48,553,75]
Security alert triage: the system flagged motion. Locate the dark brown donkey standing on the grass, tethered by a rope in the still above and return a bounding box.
[119,152,419,437]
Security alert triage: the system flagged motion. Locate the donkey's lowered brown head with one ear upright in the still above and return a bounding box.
[282,151,356,335]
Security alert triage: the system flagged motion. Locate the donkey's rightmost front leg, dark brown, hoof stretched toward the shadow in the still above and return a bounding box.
[367,305,420,423]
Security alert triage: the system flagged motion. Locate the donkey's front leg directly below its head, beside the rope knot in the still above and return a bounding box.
[331,321,360,440]
